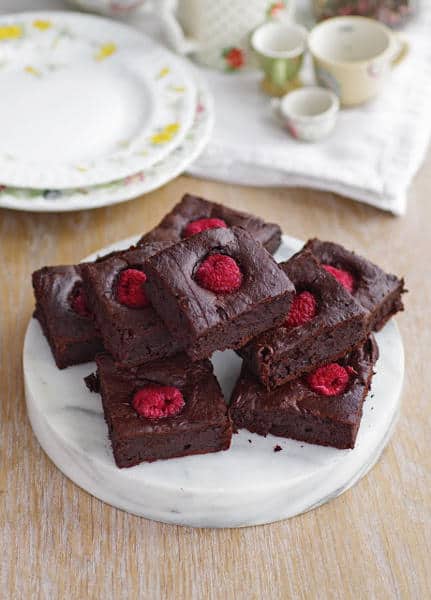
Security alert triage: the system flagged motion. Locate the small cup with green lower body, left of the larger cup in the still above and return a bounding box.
[251,22,307,96]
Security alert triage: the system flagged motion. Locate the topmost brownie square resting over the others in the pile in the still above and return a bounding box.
[145,227,294,360]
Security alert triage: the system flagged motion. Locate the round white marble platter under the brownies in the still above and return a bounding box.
[23,236,404,527]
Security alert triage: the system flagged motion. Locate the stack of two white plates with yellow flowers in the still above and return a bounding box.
[0,12,213,211]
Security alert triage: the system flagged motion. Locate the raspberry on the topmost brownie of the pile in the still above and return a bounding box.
[196,254,242,294]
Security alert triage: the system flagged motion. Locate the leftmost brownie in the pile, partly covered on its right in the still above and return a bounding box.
[32,265,103,369]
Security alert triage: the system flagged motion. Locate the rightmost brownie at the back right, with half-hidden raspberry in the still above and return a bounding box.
[305,239,406,331]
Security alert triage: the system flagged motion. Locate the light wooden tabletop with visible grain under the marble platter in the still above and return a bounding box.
[0,155,431,600]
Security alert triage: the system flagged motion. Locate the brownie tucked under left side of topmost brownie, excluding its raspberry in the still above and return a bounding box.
[82,242,181,367]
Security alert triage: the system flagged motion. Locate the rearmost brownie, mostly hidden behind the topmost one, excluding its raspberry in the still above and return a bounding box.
[138,194,281,254]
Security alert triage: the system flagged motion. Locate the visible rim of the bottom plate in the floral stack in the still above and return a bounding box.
[0,82,214,212]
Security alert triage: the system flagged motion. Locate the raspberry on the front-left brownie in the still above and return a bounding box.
[132,385,184,419]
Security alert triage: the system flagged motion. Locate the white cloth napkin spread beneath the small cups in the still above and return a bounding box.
[4,0,431,215]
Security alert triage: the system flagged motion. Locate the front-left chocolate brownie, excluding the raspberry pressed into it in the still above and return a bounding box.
[96,354,232,467]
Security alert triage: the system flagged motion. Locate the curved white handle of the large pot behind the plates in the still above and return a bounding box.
[142,0,199,54]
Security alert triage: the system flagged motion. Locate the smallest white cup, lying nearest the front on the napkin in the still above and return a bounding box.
[271,86,340,142]
